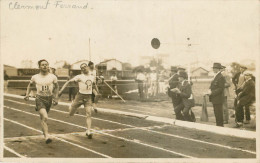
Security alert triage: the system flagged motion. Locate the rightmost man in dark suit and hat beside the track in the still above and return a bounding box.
[236,73,255,127]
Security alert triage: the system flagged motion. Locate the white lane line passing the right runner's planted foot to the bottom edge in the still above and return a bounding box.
[4,106,195,158]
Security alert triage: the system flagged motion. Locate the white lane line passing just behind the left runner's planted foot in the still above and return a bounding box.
[4,115,112,158]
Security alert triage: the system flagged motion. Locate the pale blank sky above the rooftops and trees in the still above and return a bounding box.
[1,0,259,67]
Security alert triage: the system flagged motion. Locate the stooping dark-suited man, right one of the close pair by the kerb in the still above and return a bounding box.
[172,71,193,122]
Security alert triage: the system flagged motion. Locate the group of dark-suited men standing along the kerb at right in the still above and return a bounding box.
[168,63,255,127]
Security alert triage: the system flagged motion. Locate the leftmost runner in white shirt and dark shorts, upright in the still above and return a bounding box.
[24,59,59,144]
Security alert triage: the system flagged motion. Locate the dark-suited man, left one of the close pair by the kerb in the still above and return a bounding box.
[168,66,183,120]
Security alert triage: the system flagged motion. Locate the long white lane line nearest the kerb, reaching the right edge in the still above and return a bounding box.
[3,101,256,154]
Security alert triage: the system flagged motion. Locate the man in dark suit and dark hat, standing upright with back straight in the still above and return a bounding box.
[208,63,225,127]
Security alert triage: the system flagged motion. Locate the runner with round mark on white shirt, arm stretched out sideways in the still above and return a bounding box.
[59,63,95,139]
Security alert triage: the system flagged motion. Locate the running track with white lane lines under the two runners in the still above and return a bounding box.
[4,96,256,158]
